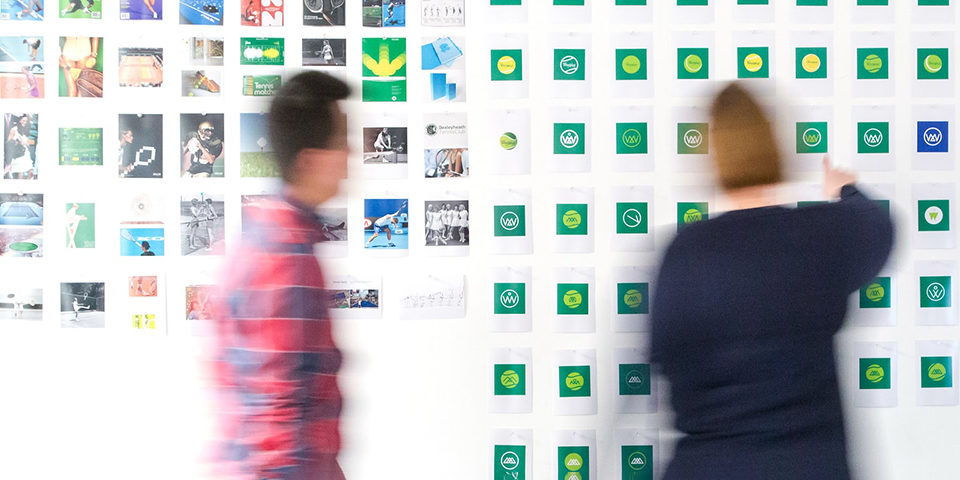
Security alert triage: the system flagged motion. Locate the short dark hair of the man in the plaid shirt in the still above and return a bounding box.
[267,71,350,182]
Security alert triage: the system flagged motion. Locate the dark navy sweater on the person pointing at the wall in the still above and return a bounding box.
[651,185,893,480]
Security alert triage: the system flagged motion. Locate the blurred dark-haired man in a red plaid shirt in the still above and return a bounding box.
[214,72,350,480]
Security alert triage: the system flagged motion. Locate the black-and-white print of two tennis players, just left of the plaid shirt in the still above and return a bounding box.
[180,192,225,256]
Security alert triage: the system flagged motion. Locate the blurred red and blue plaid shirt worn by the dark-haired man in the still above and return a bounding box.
[215,197,342,480]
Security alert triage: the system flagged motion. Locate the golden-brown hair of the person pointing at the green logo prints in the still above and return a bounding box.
[710,83,783,190]
